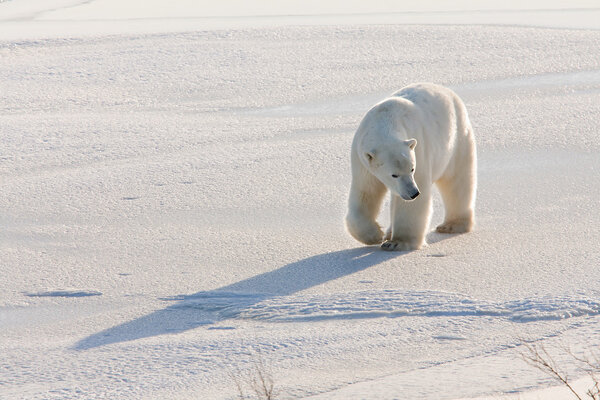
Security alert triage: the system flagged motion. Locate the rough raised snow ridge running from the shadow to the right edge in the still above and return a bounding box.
[170,290,600,322]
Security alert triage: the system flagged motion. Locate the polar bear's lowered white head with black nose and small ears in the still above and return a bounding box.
[362,139,419,201]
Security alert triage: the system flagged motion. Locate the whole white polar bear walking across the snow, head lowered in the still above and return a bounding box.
[346,83,477,251]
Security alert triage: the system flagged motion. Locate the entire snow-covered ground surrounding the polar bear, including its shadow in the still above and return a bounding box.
[0,0,600,399]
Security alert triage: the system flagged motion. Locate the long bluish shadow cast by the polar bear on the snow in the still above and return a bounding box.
[74,232,453,350]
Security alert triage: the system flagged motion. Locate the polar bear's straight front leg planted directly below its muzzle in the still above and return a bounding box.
[381,190,431,251]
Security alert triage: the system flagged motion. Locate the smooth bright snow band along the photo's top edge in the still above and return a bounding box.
[0,0,600,40]
